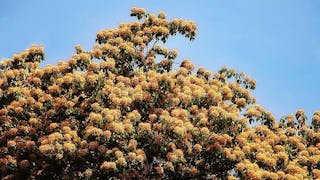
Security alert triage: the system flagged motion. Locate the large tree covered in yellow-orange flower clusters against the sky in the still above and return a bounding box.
[0,8,320,179]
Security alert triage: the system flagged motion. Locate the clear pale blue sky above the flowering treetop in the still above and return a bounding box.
[0,0,320,121]
